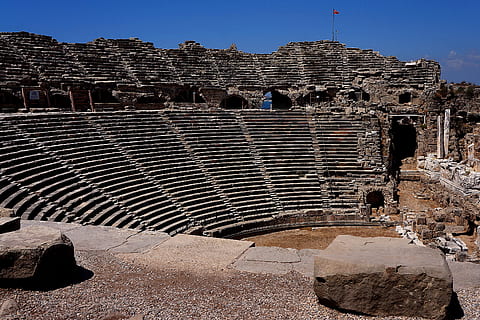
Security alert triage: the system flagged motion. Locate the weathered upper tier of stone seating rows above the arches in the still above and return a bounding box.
[0,32,439,92]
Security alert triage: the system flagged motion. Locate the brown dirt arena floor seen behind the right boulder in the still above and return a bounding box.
[243,227,399,249]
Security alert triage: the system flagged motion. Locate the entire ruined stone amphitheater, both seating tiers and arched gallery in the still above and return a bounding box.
[0,32,478,237]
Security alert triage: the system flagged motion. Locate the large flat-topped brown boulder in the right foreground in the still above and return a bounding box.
[314,235,453,319]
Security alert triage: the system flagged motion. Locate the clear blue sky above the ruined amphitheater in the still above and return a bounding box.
[0,0,480,84]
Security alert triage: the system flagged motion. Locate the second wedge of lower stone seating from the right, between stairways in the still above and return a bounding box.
[241,112,322,211]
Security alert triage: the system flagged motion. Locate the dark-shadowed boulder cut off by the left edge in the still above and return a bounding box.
[0,226,76,285]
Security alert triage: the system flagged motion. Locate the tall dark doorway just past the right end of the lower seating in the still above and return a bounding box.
[390,116,417,172]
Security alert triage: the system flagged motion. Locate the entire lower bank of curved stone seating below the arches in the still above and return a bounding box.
[0,111,386,236]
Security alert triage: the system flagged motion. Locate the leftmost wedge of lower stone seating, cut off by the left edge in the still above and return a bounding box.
[0,119,138,227]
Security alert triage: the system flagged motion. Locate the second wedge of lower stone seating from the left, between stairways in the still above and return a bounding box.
[8,115,189,233]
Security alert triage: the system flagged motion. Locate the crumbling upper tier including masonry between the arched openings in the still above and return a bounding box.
[0,32,439,108]
